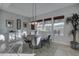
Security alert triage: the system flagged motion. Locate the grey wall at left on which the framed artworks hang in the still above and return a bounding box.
[0,10,31,34]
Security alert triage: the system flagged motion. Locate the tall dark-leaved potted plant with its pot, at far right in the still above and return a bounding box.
[66,13,79,49]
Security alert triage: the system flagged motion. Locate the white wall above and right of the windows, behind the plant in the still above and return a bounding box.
[37,4,79,45]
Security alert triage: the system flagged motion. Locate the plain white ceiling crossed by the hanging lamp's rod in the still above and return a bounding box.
[0,3,73,17]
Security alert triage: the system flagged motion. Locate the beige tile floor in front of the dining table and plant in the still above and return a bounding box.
[35,43,79,56]
